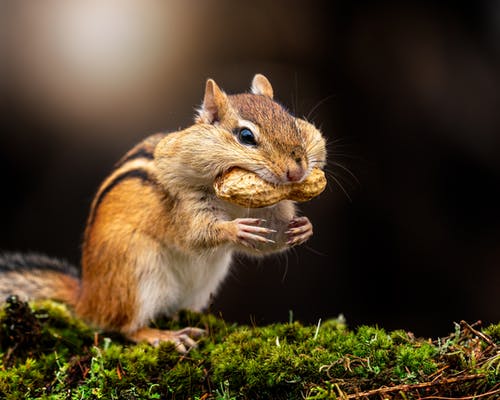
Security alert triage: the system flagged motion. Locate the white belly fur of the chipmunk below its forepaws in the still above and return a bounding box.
[136,244,232,327]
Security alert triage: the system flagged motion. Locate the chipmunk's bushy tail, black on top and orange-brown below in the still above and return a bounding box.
[0,253,80,306]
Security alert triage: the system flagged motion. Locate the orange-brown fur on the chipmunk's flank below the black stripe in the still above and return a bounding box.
[76,174,171,331]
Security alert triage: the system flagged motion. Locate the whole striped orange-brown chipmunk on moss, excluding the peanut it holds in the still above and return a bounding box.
[0,74,326,352]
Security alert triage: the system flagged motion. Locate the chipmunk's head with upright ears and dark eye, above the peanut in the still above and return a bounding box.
[196,74,326,184]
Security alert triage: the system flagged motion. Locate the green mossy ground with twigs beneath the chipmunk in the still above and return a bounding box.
[0,299,500,400]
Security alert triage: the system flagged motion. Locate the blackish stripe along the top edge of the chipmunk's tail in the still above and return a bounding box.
[0,253,80,278]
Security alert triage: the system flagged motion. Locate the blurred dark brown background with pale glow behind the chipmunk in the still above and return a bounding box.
[0,0,500,336]
